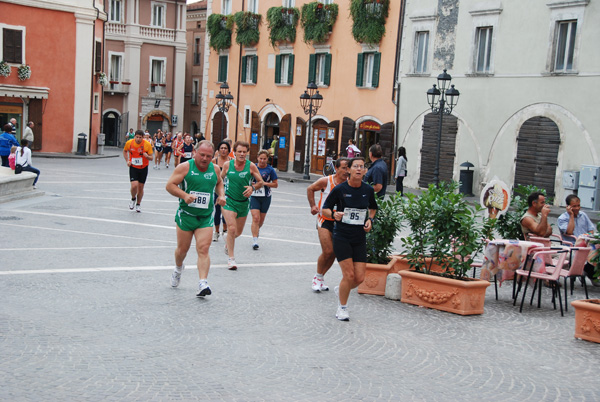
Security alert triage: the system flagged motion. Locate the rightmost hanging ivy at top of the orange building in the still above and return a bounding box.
[350,0,390,44]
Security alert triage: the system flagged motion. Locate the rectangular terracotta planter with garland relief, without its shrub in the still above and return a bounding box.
[398,271,490,315]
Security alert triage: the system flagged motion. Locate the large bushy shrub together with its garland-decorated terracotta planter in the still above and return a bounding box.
[399,182,495,315]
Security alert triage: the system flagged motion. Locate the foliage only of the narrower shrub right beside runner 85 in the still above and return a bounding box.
[367,193,402,264]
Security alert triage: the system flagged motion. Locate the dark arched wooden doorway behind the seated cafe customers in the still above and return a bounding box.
[514,116,560,196]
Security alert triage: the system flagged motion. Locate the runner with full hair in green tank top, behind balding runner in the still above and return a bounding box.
[221,141,264,270]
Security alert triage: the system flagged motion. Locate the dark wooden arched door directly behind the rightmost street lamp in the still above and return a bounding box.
[419,113,458,187]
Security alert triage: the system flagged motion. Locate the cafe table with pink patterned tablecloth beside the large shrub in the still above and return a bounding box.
[480,239,545,284]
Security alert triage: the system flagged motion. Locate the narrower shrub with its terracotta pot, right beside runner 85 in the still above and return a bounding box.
[358,193,408,296]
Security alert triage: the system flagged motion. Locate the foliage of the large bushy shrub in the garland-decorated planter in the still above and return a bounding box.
[400,182,495,279]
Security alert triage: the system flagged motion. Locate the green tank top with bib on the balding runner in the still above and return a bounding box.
[179,159,218,216]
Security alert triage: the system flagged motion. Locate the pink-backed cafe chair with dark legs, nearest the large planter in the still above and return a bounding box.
[515,247,569,316]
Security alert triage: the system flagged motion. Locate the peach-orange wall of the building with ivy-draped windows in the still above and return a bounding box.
[203,0,400,169]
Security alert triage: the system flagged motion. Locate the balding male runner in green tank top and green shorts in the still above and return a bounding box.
[166,140,226,297]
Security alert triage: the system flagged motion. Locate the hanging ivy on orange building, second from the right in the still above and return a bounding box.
[301,1,339,43]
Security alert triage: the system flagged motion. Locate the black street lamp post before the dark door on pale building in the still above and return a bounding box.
[427,70,460,186]
